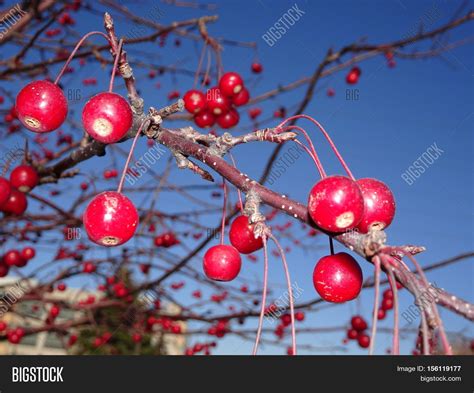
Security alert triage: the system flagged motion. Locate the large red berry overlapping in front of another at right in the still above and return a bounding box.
[308,176,364,232]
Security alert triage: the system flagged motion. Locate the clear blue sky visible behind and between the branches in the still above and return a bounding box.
[0,0,474,354]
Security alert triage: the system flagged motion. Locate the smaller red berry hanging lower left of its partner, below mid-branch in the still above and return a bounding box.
[203,244,242,281]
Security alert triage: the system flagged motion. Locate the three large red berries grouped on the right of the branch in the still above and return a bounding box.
[308,176,395,303]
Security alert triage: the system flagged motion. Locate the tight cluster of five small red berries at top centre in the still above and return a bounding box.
[183,72,250,129]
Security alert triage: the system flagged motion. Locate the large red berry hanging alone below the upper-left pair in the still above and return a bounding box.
[83,191,138,247]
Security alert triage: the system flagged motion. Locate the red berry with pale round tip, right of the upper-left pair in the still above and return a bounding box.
[82,92,133,143]
